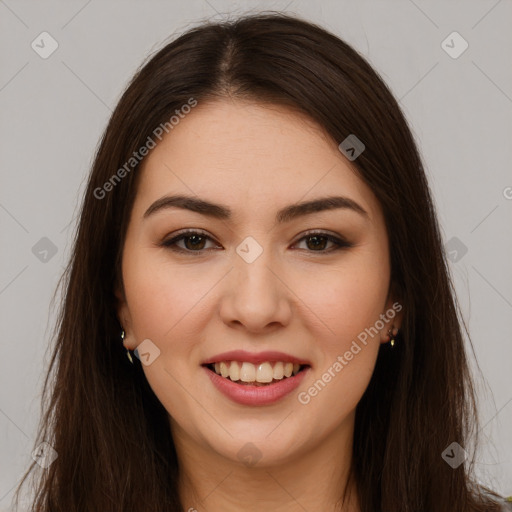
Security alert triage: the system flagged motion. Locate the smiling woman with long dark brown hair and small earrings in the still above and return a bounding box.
[14,14,510,512]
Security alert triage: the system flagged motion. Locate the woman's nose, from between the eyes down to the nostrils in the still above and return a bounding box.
[220,245,295,333]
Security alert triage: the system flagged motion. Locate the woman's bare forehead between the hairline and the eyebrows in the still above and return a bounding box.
[136,100,379,223]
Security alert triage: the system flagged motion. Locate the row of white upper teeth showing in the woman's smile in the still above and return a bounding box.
[214,361,306,384]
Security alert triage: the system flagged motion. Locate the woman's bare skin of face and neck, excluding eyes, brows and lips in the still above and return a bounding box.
[117,100,402,512]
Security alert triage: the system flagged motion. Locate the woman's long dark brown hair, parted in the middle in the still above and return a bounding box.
[16,13,506,512]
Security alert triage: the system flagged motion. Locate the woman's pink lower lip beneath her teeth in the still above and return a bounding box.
[203,366,310,405]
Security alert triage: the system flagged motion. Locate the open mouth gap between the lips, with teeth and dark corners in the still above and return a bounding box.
[202,361,310,387]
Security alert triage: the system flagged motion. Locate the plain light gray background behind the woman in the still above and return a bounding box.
[0,0,512,511]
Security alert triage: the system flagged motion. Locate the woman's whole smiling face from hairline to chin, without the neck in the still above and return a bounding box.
[118,101,401,466]
